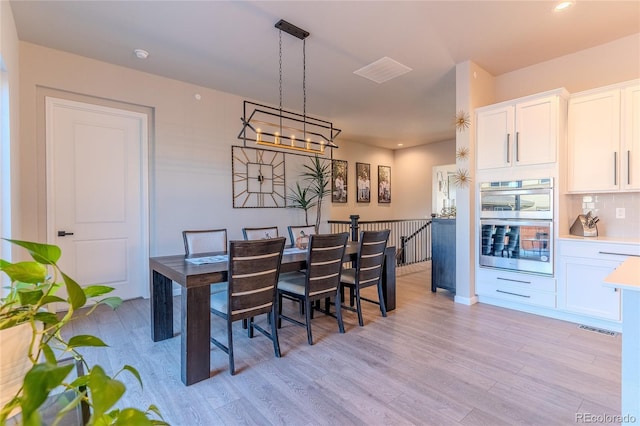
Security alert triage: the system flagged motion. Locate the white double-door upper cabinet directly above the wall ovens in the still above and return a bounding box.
[476,91,566,170]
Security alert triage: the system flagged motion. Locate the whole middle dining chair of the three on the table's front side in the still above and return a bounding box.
[278,232,349,345]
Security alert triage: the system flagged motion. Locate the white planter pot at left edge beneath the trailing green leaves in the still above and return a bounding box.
[0,322,42,417]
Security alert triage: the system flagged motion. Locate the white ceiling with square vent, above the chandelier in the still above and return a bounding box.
[10,0,640,149]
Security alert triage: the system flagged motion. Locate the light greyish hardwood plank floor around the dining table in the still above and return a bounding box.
[66,262,621,426]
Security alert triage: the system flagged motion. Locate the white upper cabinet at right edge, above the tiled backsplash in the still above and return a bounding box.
[567,81,640,192]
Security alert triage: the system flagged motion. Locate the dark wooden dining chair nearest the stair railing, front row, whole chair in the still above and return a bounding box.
[336,229,391,327]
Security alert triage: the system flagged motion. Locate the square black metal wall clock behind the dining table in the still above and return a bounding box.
[231,146,286,208]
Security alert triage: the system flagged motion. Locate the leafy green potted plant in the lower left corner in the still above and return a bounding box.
[0,240,166,425]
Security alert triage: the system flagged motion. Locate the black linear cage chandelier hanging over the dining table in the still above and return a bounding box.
[238,19,341,154]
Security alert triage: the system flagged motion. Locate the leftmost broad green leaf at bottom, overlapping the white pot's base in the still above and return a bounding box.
[20,363,73,418]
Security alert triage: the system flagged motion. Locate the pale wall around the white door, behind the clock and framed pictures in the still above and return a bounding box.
[17,42,395,255]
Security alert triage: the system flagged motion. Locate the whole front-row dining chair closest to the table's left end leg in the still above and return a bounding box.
[210,237,286,375]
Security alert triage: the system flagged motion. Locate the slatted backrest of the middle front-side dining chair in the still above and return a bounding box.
[305,232,349,297]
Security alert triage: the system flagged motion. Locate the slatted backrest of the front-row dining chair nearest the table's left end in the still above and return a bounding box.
[228,237,286,321]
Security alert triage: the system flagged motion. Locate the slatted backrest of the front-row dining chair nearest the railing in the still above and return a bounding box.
[357,229,390,287]
